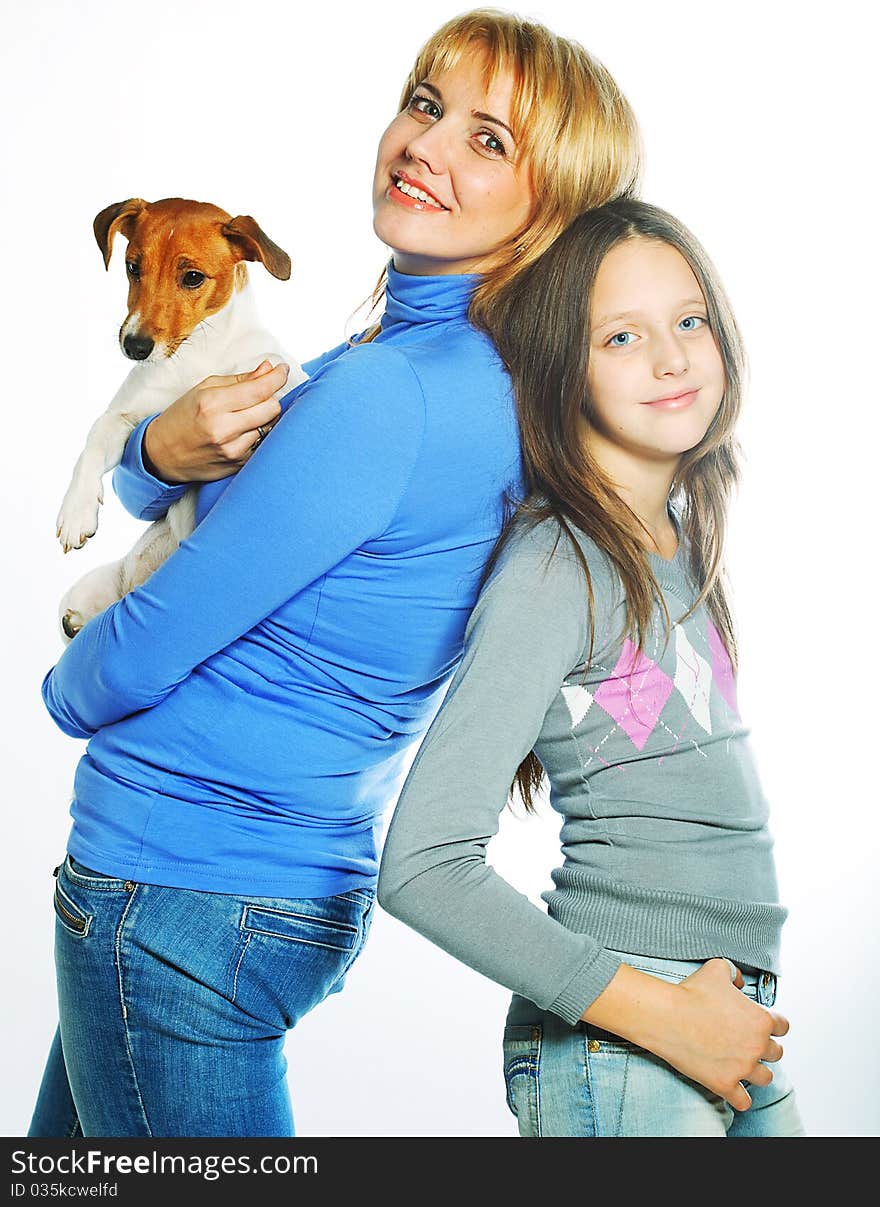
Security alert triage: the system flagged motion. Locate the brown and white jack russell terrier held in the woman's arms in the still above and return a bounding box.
[56,197,307,643]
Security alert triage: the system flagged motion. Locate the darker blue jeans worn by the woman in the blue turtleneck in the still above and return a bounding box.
[29,856,374,1136]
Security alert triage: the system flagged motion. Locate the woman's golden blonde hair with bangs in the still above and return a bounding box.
[365,8,641,338]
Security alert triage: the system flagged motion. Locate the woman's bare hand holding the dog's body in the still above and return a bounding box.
[142,361,290,483]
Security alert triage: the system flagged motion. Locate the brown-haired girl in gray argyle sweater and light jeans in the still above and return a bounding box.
[379,199,803,1137]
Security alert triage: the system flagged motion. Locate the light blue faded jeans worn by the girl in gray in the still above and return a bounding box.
[503,951,804,1137]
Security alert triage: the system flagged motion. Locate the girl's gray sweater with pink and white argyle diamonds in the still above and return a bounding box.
[379,520,786,1024]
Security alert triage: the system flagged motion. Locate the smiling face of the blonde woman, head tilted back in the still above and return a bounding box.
[373,53,534,276]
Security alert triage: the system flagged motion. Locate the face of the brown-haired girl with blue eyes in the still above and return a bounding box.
[588,237,724,465]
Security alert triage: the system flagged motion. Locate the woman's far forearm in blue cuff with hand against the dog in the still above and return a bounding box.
[113,343,349,520]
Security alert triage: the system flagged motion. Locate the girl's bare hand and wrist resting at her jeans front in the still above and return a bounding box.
[583,960,788,1110]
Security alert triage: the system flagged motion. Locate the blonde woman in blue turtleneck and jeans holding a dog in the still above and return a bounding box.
[31,11,639,1136]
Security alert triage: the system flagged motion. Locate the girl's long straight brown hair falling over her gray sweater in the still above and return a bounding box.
[479,198,745,809]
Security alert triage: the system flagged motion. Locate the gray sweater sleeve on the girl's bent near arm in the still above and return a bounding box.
[378,525,620,1025]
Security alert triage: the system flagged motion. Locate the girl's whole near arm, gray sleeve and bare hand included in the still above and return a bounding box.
[378,531,787,1109]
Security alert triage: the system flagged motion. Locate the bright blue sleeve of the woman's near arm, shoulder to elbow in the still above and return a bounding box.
[42,344,425,737]
